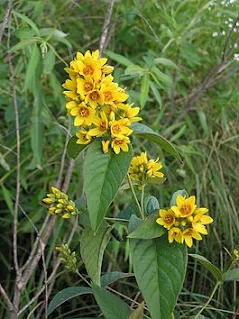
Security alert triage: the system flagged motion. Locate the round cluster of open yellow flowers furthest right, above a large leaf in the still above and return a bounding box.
[156,195,213,247]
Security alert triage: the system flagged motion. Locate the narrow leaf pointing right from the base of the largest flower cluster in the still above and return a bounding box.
[131,123,181,160]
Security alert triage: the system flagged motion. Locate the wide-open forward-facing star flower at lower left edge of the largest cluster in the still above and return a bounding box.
[70,102,95,126]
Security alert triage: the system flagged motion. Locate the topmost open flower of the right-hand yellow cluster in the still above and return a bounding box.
[171,195,197,218]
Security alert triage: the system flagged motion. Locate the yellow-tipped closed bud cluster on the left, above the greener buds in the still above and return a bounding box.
[42,187,79,219]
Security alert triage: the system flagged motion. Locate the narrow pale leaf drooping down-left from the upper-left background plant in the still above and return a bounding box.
[24,44,41,90]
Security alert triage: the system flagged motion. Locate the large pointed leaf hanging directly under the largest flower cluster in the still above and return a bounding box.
[84,140,132,231]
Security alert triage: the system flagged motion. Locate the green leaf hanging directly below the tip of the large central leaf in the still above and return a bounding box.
[80,222,112,286]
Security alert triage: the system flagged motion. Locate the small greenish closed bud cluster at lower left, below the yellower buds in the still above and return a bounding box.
[55,244,78,273]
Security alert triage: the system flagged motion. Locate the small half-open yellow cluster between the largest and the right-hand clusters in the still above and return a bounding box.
[129,152,164,186]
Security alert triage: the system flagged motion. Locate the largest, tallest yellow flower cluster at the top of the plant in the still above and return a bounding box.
[63,50,141,154]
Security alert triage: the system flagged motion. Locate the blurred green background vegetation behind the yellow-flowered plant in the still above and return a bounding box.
[0,0,239,318]
